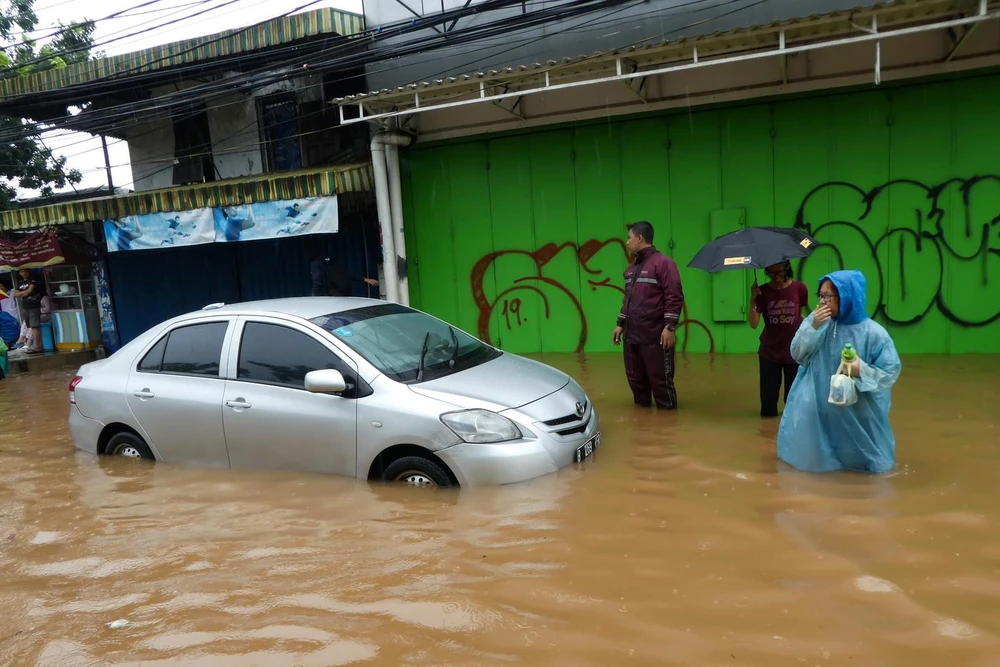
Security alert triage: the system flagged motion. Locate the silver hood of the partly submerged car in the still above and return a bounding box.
[410,352,569,411]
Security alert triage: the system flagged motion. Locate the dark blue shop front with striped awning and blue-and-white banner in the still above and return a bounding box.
[0,165,381,353]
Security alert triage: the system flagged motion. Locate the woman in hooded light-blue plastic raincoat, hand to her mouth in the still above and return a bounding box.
[778,271,902,473]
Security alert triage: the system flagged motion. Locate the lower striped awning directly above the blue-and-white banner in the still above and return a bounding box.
[0,164,374,231]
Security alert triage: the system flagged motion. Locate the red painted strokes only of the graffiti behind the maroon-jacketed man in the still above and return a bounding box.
[470,238,715,354]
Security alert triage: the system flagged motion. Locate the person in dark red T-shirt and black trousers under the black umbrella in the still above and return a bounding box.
[748,262,809,417]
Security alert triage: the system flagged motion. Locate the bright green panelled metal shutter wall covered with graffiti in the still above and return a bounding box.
[402,76,1000,353]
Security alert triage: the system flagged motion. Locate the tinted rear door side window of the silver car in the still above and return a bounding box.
[138,322,229,377]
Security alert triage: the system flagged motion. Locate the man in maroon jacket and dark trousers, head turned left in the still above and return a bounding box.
[612,221,684,410]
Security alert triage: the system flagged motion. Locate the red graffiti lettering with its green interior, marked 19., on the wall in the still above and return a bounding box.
[471,239,715,352]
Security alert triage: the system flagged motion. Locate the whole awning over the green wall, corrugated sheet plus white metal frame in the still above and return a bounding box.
[331,0,1000,124]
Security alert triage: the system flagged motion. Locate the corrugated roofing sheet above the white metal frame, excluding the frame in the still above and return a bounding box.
[333,0,968,106]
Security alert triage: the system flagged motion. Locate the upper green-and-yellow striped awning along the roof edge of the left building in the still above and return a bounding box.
[0,9,365,98]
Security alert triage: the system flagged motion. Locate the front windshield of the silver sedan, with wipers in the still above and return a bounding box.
[310,303,502,384]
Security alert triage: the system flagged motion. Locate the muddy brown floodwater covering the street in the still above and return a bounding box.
[0,355,1000,667]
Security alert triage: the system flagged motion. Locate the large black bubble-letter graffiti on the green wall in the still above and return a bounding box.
[795,176,1000,327]
